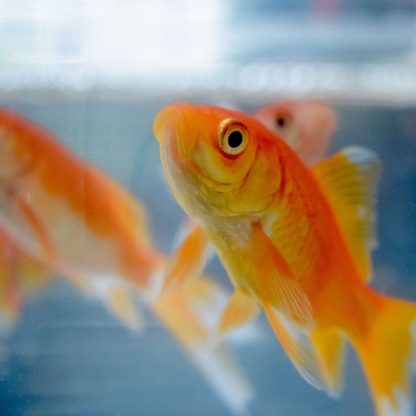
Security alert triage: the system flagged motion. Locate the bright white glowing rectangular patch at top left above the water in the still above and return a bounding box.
[0,0,223,72]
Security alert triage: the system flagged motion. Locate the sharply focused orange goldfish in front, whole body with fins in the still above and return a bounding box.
[154,103,416,416]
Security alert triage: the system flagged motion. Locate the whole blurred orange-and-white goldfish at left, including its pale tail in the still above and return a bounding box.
[0,109,252,413]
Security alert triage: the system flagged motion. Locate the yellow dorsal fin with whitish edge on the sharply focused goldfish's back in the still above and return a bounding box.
[313,146,381,282]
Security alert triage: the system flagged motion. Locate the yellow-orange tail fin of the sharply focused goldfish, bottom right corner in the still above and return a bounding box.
[353,297,416,416]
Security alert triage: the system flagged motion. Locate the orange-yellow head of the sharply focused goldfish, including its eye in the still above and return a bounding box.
[154,103,281,216]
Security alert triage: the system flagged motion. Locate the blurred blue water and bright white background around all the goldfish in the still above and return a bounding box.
[0,0,416,416]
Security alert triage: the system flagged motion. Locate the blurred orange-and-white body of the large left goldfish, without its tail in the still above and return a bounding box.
[0,110,161,306]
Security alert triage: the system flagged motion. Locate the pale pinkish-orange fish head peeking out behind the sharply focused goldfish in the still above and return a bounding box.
[255,101,336,166]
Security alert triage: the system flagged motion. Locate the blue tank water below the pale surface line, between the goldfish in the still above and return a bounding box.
[0,99,416,416]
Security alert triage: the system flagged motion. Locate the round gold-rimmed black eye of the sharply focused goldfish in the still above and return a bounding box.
[219,119,249,155]
